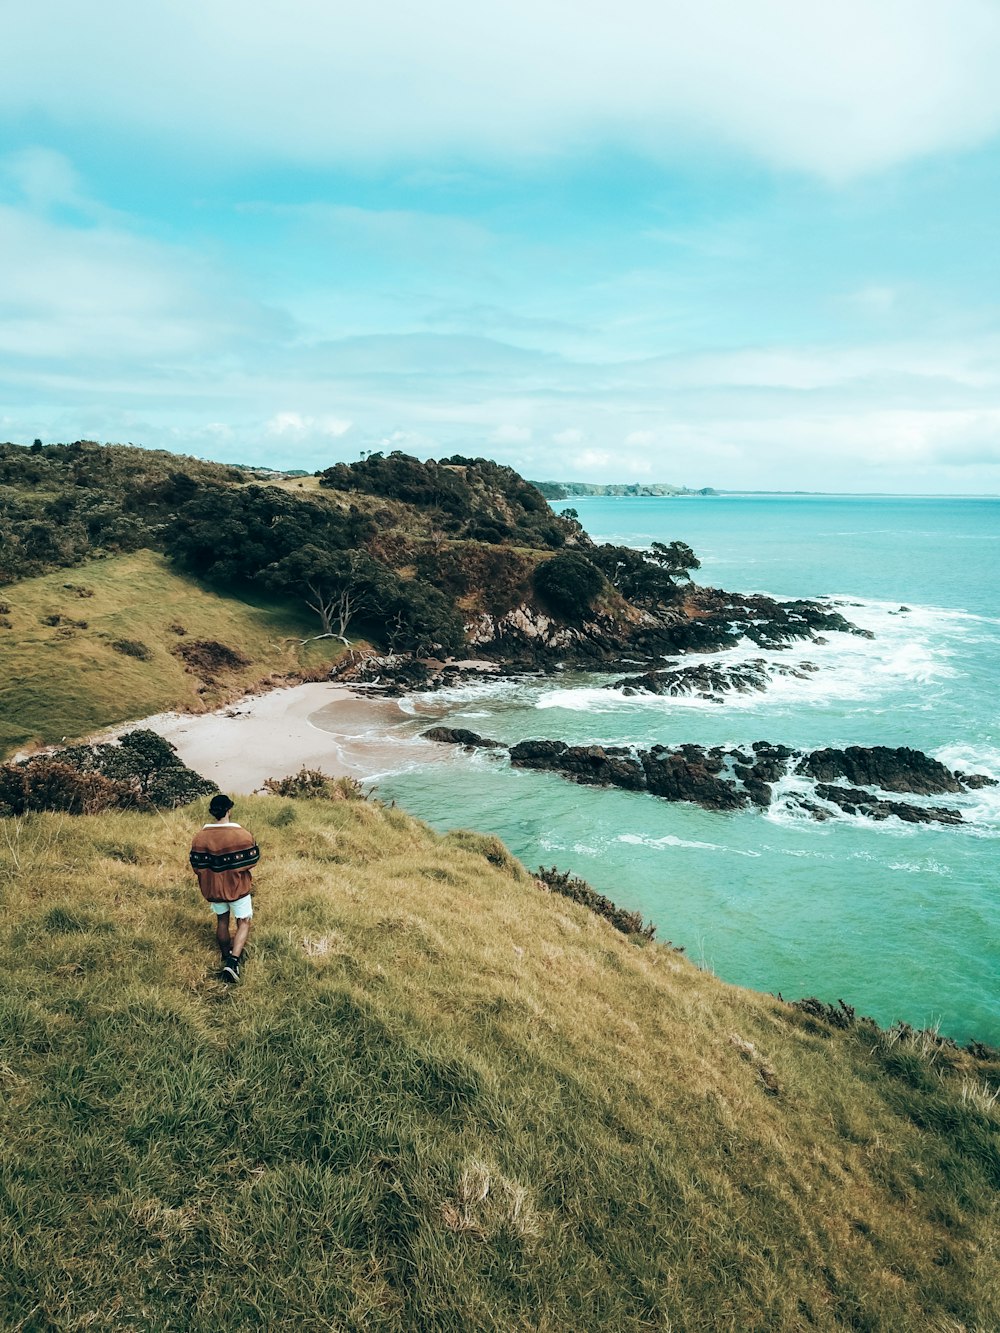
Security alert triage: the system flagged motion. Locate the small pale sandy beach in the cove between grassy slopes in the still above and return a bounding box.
[112,682,435,794]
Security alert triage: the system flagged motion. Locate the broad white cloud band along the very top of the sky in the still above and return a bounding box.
[7,0,1000,179]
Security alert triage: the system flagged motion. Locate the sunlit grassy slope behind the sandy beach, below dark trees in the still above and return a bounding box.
[0,551,343,757]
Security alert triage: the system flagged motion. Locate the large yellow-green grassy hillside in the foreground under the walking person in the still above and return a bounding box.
[0,797,1000,1333]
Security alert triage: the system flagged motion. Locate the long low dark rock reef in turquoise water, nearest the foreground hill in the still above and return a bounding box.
[424,728,996,824]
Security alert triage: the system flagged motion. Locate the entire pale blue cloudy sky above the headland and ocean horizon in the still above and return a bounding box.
[0,0,1000,493]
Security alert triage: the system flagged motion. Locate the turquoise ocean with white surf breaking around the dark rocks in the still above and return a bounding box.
[322,495,1000,1045]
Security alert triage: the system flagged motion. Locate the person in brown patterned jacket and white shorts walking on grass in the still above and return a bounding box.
[191,792,260,981]
